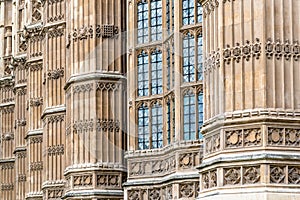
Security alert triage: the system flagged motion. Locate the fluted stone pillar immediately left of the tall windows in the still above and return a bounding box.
[65,0,126,199]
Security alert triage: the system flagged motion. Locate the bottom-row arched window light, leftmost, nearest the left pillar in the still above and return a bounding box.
[138,106,149,150]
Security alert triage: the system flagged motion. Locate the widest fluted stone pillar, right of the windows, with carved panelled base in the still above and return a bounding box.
[199,0,300,200]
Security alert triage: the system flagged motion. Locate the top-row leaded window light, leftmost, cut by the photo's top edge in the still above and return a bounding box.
[137,2,148,44]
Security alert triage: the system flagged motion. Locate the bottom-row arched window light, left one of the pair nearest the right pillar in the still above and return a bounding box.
[183,92,196,140]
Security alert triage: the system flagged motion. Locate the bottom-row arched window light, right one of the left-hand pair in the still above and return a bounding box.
[151,104,163,149]
